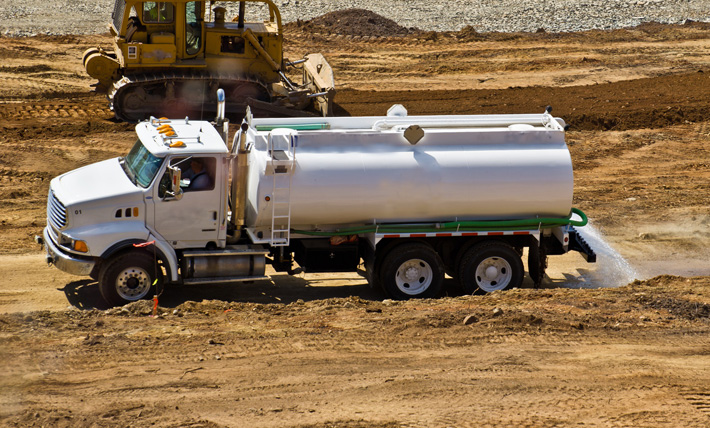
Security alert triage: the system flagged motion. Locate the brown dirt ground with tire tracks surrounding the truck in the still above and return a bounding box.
[0,17,710,427]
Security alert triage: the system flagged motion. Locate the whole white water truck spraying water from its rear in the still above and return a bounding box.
[37,90,596,305]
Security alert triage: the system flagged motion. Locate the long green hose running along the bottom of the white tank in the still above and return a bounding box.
[291,208,588,236]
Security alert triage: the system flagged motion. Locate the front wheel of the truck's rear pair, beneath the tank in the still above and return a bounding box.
[380,243,444,300]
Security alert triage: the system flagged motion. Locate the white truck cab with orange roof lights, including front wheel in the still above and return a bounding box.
[43,118,234,303]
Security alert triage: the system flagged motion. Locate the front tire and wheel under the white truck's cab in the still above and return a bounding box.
[99,252,163,306]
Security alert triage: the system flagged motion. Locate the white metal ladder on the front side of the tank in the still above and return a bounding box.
[267,129,296,247]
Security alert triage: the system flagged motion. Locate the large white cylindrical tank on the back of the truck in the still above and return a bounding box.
[246,110,573,230]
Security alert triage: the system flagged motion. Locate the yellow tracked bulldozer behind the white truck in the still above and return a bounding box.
[83,0,335,122]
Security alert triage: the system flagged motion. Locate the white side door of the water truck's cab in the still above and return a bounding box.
[152,156,223,249]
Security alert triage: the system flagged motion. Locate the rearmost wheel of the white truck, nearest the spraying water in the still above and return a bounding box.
[458,242,525,294]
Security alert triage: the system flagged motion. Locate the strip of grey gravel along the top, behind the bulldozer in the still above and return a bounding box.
[0,0,710,36]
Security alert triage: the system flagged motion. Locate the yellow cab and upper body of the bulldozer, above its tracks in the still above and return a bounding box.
[111,0,283,73]
